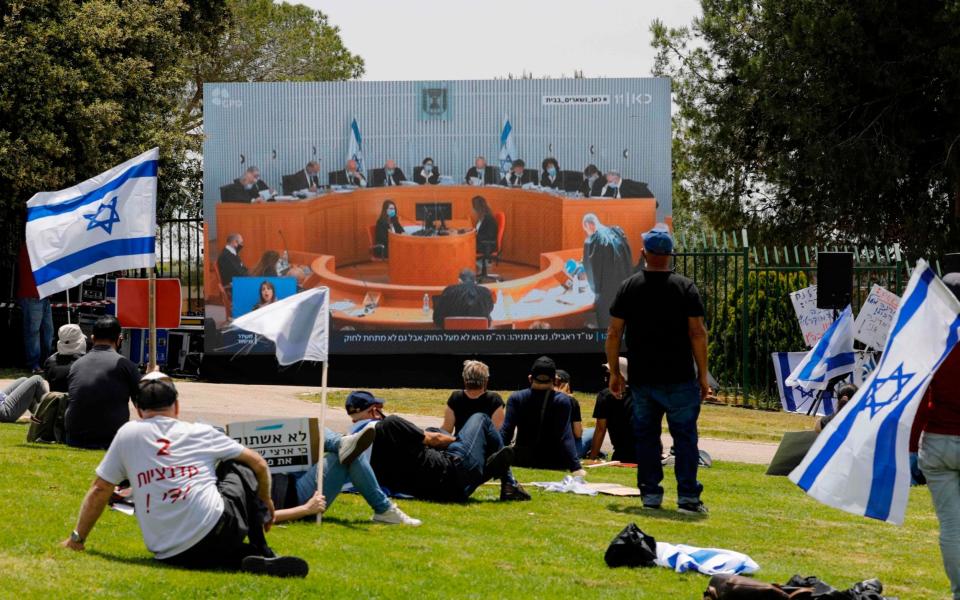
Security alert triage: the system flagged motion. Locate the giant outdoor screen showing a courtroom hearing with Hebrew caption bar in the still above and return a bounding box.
[203,78,671,354]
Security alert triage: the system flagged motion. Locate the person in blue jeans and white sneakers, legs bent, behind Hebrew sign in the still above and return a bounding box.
[272,424,421,527]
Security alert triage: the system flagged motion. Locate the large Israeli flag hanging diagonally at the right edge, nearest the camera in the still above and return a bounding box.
[790,260,960,525]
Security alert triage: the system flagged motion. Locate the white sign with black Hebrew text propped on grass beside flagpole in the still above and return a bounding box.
[227,418,320,473]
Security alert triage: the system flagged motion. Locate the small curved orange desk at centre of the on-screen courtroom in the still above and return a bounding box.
[388,229,477,286]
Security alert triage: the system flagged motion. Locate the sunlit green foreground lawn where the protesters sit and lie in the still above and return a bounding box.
[0,425,949,600]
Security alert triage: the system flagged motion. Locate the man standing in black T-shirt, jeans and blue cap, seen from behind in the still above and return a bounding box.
[606,223,710,514]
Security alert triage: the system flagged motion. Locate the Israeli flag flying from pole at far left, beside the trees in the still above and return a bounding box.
[26,148,160,298]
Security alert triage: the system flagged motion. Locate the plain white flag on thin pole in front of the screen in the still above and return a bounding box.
[231,287,330,366]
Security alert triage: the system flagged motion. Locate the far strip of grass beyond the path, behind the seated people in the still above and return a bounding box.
[306,388,813,443]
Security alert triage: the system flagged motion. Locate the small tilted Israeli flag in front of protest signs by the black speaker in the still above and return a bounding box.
[787,304,857,390]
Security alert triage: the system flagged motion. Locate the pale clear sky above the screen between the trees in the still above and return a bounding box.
[299,0,700,81]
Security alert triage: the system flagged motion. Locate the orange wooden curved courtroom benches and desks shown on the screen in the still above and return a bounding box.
[207,186,656,329]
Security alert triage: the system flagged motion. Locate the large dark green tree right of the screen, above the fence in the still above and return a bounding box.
[652,0,960,255]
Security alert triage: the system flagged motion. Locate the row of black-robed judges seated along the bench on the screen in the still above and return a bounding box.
[220,156,653,202]
